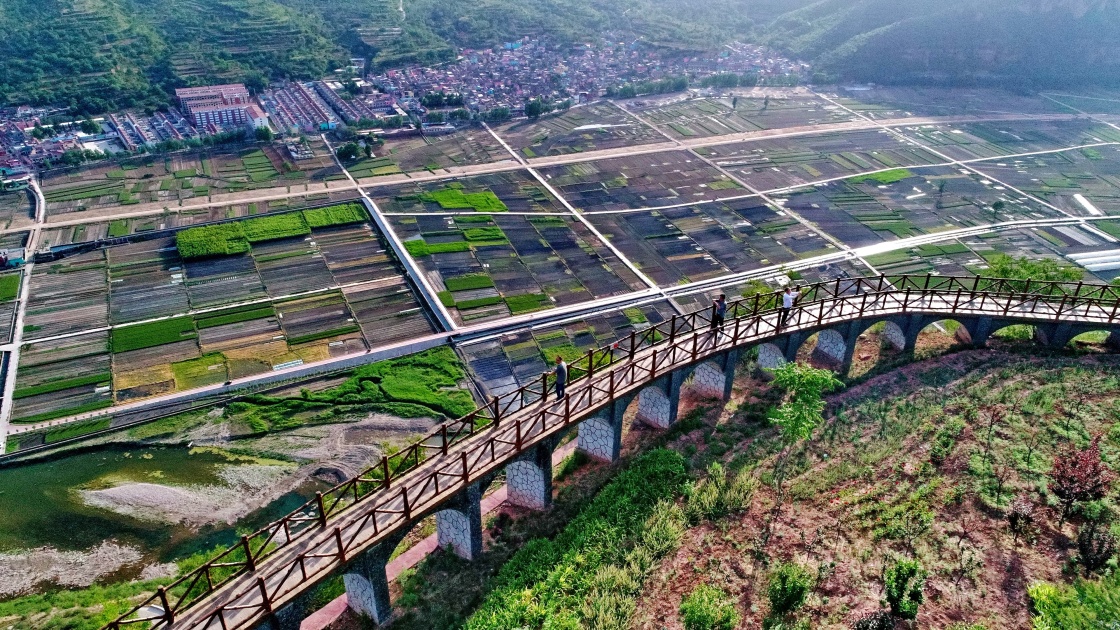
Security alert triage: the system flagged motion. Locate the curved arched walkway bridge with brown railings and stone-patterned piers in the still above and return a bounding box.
[106,276,1120,630]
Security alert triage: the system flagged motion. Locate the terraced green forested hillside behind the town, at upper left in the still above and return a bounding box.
[0,0,761,112]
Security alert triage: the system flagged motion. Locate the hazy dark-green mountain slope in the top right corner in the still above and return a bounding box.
[759,0,1120,89]
